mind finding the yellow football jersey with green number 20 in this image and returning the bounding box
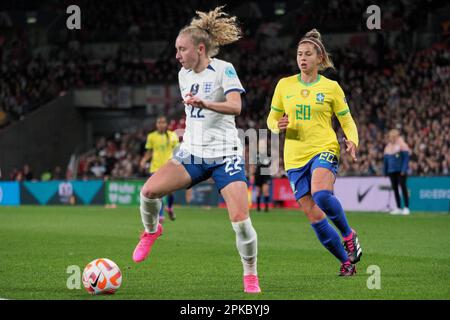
[267,74,359,170]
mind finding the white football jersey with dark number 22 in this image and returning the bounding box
[178,58,245,158]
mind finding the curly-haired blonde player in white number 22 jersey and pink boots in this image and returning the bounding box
[133,7,261,293]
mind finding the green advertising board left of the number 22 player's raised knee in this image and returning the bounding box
[105,180,145,206]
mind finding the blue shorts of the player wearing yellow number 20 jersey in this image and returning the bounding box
[287,152,339,201]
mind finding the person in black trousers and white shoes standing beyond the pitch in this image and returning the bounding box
[384,129,410,215]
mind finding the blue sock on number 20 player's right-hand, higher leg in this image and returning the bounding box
[313,190,352,238]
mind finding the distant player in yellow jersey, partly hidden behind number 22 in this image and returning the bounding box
[141,116,179,222]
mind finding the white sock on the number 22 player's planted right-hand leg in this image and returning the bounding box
[231,217,258,275]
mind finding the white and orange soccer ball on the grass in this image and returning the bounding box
[83,258,122,294]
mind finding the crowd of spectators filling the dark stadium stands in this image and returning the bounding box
[0,0,450,178]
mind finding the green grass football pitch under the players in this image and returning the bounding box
[0,206,450,300]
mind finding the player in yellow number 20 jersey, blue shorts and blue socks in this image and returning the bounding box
[267,29,362,276]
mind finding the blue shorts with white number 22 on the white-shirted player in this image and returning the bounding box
[173,151,248,192]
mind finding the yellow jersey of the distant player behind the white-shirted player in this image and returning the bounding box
[145,130,178,173]
